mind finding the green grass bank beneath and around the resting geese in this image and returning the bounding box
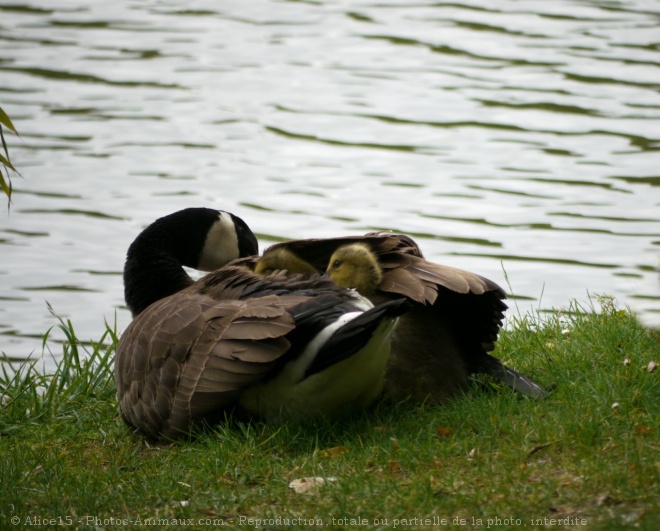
[0,298,660,530]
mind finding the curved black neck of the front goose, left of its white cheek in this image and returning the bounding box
[124,208,230,316]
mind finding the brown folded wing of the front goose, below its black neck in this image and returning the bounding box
[115,289,295,437]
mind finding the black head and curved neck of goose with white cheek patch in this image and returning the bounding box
[124,208,258,316]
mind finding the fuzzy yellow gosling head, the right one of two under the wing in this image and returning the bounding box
[326,243,383,297]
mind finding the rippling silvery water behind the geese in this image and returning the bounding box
[0,0,660,366]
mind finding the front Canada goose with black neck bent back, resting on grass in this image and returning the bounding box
[115,208,408,438]
